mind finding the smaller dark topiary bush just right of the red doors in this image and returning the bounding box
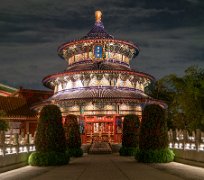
[119,114,140,156]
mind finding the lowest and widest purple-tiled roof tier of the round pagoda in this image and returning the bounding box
[33,88,166,107]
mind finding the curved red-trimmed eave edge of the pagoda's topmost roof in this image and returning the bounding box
[57,39,140,59]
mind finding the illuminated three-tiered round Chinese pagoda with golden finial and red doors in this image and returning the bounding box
[35,11,164,144]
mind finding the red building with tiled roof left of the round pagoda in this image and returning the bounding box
[0,84,53,135]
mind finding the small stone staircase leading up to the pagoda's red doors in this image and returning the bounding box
[89,142,112,154]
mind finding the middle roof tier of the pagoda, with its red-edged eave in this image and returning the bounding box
[42,63,155,89]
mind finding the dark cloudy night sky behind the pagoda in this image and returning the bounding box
[0,0,204,89]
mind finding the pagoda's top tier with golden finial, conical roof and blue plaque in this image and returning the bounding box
[58,11,139,65]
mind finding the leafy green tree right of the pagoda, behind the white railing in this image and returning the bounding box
[150,66,204,131]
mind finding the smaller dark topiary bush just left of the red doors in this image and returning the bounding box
[64,115,83,157]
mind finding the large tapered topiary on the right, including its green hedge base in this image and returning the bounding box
[135,105,174,163]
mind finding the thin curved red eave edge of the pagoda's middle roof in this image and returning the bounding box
[42,70,155,89]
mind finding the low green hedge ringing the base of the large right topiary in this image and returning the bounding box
[135,148,175,163]
